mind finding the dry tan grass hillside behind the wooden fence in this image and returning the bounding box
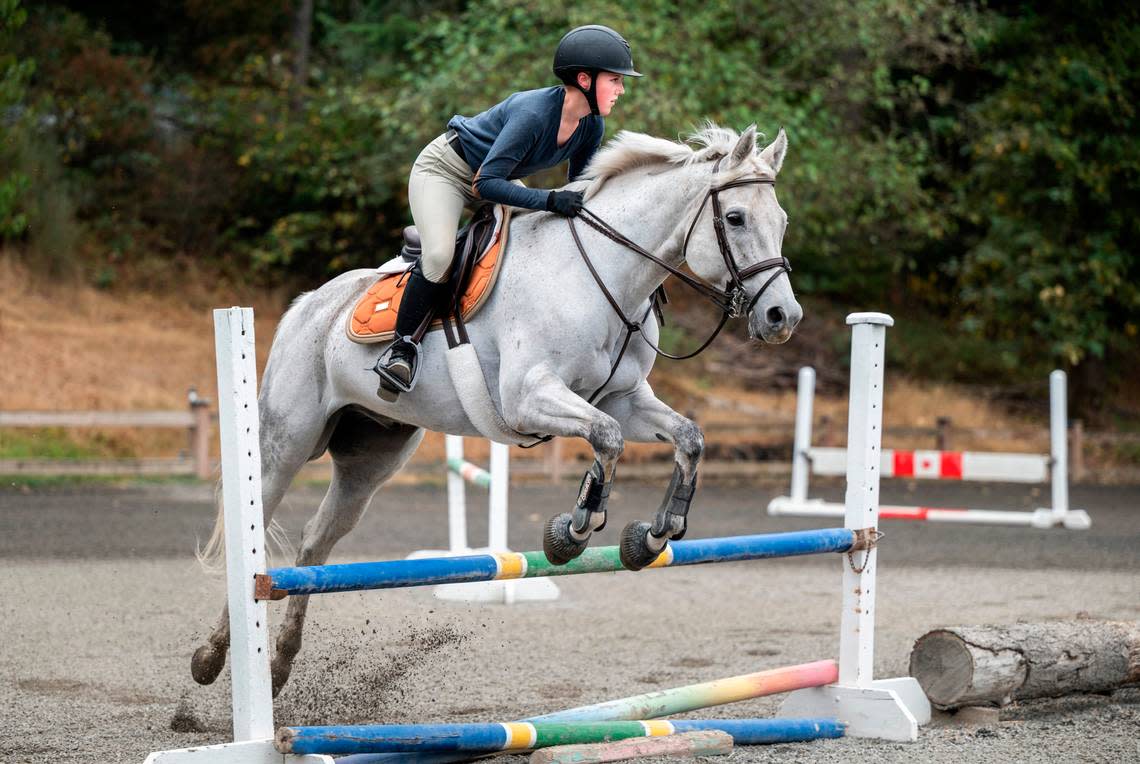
[0,259,1044,472]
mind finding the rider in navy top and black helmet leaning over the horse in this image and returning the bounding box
[374,25,641,398]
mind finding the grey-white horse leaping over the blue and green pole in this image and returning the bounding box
[192,125,803,693]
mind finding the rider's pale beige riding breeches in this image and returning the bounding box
[408,135,521,284]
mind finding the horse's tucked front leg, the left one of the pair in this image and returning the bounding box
[505,365,625,566]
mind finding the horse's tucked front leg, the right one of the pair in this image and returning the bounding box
[600,381,705,570]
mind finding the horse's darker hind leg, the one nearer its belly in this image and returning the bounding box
[271,413,423,696]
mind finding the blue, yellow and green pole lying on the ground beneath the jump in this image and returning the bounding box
[274,718,846,755]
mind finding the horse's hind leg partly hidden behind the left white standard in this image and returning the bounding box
[190,406,333,684]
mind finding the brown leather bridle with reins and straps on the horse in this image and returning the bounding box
[567,157,791,403]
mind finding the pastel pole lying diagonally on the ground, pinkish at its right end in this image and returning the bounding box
[337,660,839,764]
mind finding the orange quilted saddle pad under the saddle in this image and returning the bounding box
[345,205,511,344]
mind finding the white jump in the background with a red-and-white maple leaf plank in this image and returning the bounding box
[768,366,1091,530]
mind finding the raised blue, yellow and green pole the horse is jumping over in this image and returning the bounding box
[254,528,872,600]
